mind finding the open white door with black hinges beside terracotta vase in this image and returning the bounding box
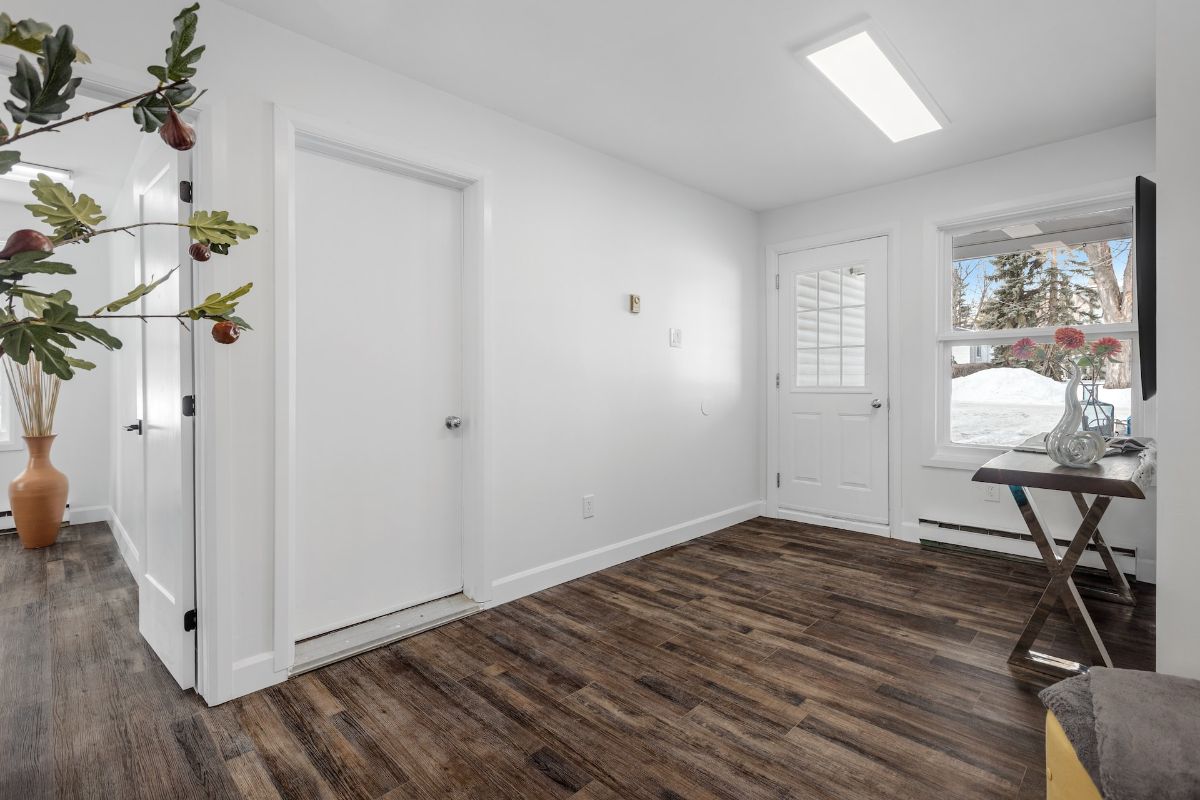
[136,154,196,688]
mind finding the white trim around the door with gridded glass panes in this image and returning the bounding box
[762,222,904,536]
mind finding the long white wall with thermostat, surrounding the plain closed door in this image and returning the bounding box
[28,0,763,700]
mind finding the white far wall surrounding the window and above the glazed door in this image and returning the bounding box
[760,121,1154,579]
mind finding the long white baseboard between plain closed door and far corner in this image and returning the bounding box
[485,500,763,608]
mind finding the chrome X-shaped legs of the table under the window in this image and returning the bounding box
[1008,486,1113,675]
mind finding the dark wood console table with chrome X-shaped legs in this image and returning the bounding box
[972,435,1157,675]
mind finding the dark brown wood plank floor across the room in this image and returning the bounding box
[0,519,1154,800]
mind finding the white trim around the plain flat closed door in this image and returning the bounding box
[274,104,492,673]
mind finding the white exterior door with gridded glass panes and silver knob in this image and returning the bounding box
[778,236,888,524]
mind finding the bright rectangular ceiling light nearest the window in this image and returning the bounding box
[796,22,948,142]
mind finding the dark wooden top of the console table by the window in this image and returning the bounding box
[971,435,1157,500]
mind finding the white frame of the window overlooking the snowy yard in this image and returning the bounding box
[925,193,1152,469]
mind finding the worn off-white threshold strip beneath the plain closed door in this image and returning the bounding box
[288,594,481,675]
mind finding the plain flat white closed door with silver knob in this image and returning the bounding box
[292,149,470,640]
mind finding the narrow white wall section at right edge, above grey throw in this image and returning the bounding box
[1157,0,1200,678]
